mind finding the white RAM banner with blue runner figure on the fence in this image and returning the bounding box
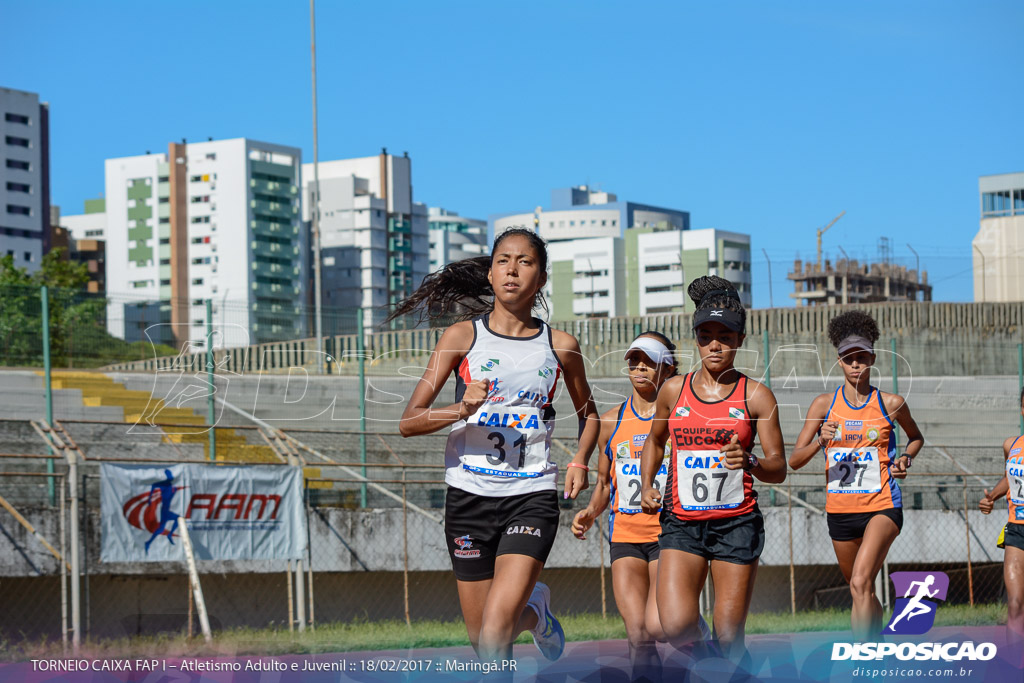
[100,463,306,562]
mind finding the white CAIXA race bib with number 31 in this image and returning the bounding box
[463,405,548,477]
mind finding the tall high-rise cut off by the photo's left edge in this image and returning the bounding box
[0,88,50,272]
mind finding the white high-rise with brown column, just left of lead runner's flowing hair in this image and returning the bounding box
[302,150,430,336]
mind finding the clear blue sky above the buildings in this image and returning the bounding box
[0,0,1024,306]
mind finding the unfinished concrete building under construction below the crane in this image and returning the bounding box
[786,258,932,306]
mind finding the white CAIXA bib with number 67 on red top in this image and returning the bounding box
[676,451,743,510]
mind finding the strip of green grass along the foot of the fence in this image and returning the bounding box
[0,604,1007,660]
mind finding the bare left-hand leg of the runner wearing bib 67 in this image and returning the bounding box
[657,547,708,648]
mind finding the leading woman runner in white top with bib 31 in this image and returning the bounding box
[392,228,600,660]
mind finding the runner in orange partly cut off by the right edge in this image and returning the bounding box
[978,391,1024,643]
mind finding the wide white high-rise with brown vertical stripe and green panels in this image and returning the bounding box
[103,138,307,347]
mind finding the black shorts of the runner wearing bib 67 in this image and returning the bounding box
[657,507,765,564]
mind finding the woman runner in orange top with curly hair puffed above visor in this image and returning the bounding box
[790,310,925,640]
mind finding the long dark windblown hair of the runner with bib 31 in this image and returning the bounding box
[384,227,548,324]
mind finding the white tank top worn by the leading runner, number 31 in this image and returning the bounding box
[444,314,562,497]
